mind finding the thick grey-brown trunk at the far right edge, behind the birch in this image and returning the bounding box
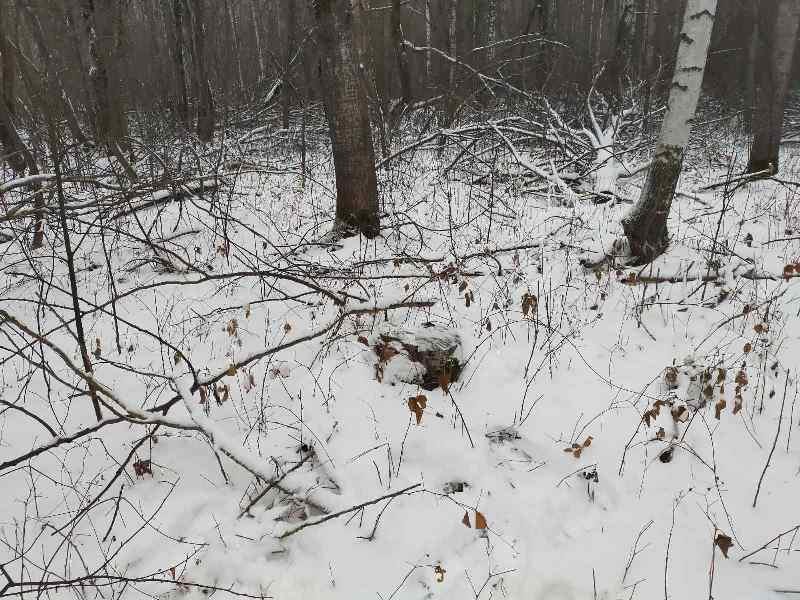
[747,0,800,175]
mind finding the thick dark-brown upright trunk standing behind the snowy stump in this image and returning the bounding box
[314,0,380,238]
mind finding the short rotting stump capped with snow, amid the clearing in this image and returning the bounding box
[372,325,463,390]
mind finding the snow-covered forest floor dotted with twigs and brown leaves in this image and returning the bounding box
[0,115,800,600]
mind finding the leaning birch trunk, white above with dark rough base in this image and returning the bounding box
[622,0,717,264]
